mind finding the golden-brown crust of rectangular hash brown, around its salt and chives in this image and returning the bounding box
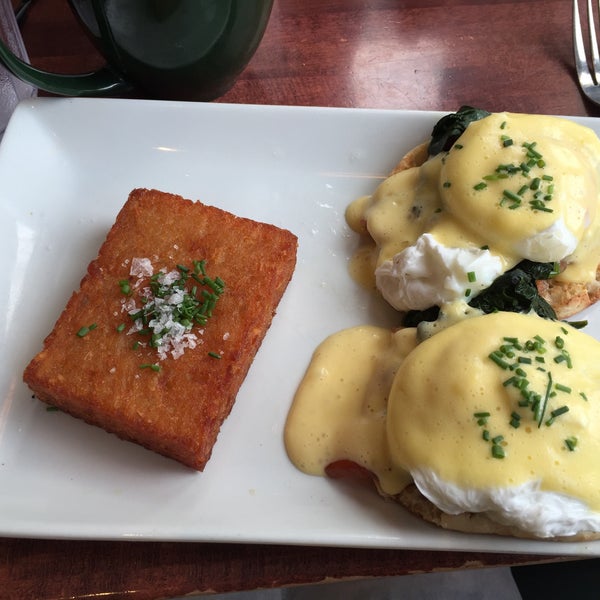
[24,189,297,470]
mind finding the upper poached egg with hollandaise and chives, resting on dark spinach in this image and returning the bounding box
[347,113,600,310]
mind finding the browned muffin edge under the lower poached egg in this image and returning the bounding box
[394,484,600,542]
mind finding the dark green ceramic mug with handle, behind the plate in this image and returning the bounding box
[0,0,273,100]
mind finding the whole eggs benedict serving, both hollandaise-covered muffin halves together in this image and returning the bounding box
[285,109,600,541]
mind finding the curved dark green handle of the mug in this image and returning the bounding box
[0,10,132,96]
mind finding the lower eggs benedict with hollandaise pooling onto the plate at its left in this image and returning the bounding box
[285,312,600,540]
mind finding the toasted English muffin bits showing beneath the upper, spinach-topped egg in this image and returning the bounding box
[390,142,600,319]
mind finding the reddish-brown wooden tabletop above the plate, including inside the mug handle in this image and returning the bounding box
[16,0,600,115]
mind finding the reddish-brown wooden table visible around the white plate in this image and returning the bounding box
[0,0,598,600]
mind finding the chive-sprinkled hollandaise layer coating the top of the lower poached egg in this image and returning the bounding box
[387,313,600,512]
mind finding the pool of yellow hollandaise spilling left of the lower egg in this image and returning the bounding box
[285,326,416,494]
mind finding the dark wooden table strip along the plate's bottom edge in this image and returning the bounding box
[0,539,568,600]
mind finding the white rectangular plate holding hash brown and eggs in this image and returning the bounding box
[0,99,600,555]
